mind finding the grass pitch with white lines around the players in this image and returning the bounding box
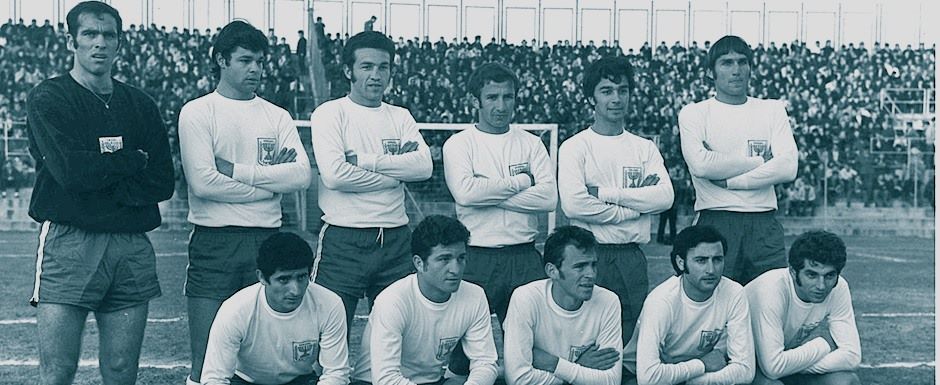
[0,232,936,385]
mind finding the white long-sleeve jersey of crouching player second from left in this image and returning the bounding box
[352,274,498,385]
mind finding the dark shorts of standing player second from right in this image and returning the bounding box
[597,243,650,344]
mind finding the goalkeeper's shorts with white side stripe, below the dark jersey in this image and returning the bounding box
[30,221,161,313]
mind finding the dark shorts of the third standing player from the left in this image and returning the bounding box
[313,224,414,300]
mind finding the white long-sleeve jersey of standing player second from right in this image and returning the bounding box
[558,128,674,244]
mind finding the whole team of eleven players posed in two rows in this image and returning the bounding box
[27,1,860,385]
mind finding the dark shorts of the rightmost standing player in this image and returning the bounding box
[696,210,787,285]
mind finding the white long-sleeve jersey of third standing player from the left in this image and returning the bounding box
[310,96,433,228]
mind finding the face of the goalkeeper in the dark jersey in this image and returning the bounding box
[67,13,120,76]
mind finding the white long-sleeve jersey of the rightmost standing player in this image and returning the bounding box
[679,97,799,212]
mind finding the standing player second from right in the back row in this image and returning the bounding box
[558,57,673,342]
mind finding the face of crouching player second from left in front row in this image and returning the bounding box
[414,242,467,302]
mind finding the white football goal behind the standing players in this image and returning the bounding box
[293,120,558,234]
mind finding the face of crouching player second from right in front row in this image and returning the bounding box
[678,242,725,301]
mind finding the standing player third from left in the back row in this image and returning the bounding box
[310,31,432,326]
